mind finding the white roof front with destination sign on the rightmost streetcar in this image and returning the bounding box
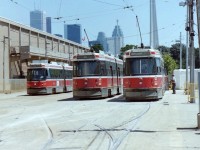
[124,48,162,58]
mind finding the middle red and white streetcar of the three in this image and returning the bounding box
[73,51,123,98]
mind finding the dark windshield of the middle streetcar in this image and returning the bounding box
[73,61,100,77]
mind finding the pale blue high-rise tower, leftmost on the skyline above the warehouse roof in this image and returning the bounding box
[30,10,46,31]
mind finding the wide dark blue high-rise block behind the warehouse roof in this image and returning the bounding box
[64,24,82,44]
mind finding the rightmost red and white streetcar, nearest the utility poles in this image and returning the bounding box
[123,49,168,100]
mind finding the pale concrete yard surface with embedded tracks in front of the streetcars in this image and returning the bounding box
[0,91,200,150]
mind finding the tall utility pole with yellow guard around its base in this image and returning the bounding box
[188,0,195,103]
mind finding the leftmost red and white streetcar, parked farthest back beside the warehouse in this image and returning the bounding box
[27,60,72,95]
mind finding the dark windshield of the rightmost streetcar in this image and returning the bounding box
[124,58,157,76]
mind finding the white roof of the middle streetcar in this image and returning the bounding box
[72,52,123,64]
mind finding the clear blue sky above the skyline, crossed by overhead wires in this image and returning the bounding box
[0,0,198,47]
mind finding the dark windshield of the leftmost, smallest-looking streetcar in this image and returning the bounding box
[27,68,47,81]
